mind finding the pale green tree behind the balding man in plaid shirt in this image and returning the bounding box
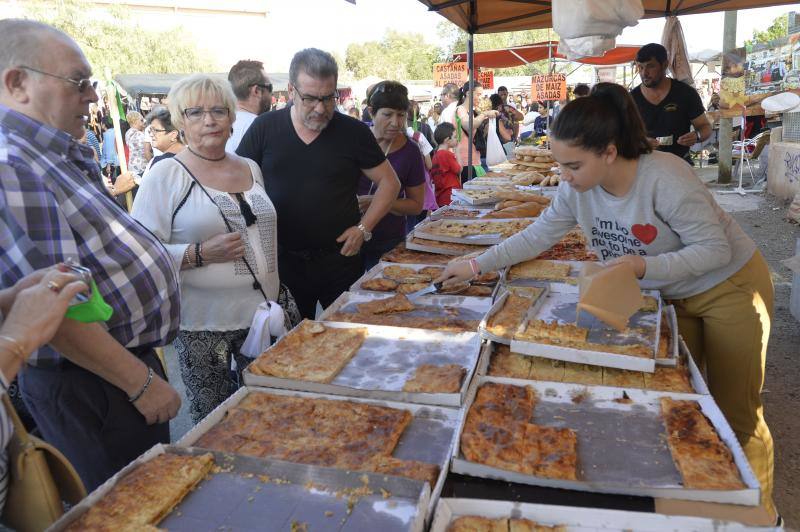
[25,0,214,76]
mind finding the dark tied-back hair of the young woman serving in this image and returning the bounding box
[551,83,653,159]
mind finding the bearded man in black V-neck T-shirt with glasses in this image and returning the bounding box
[236,48,400,319]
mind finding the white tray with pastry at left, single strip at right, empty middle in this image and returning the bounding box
[452,377,760,506]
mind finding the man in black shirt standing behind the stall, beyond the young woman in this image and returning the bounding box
[631,43,711,158]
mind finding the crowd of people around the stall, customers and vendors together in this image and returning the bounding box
[0,19,772,524]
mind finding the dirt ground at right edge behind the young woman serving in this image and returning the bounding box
[713,187,800,529]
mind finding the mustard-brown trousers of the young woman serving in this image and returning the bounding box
[670,250,775,513]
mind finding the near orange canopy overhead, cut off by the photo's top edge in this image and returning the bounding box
[419,0,796,34]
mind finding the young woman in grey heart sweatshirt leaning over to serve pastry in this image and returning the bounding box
[438,83,773,510]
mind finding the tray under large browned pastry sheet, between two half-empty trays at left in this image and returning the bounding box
[176,386,463,520]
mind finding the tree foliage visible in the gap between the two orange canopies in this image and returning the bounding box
[436,20,558,76]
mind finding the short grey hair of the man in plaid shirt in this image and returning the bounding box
[0,18,75,72]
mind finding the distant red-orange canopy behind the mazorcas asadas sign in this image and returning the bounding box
[453,41,640,68]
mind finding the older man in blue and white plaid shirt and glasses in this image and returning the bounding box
[0,19,180,490]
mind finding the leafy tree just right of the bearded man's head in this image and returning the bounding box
[344,30,441,80]
